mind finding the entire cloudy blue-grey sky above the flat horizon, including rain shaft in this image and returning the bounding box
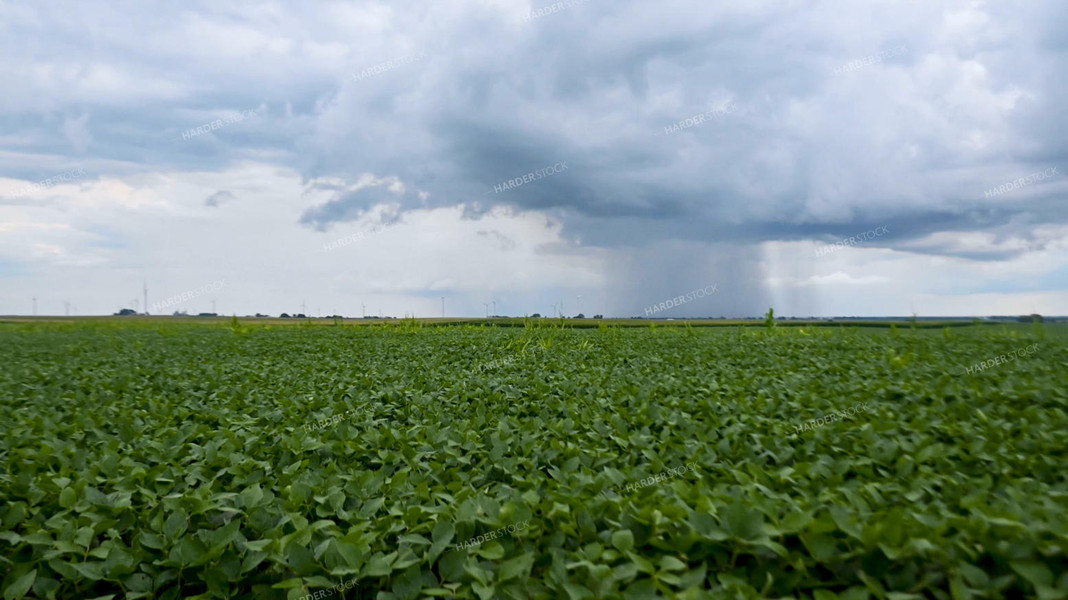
[0,0,1068,318]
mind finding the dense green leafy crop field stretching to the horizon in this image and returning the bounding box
[0,317,1068,600]
